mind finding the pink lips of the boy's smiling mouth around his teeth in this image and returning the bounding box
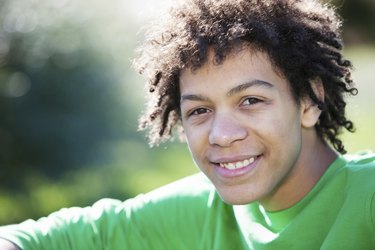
[213,155,262,179]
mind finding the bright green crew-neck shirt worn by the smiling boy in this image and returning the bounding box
[0,153,375,250]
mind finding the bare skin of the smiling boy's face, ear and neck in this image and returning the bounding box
[179,47,337,211]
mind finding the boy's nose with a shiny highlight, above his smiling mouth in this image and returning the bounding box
[208,114,247,147]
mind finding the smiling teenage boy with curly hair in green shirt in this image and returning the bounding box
[0,0,375,250]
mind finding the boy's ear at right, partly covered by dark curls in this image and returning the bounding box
[301,78,324,128]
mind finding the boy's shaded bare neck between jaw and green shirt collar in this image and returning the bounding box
[260,129,338,211]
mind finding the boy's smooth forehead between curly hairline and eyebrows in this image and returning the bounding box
[180,47,289,93]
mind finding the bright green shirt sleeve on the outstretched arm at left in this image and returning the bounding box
[0,174,214,250]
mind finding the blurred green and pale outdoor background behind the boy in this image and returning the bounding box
[0,0,375,225]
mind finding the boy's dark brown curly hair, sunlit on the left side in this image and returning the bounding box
[135,0,357,153]
